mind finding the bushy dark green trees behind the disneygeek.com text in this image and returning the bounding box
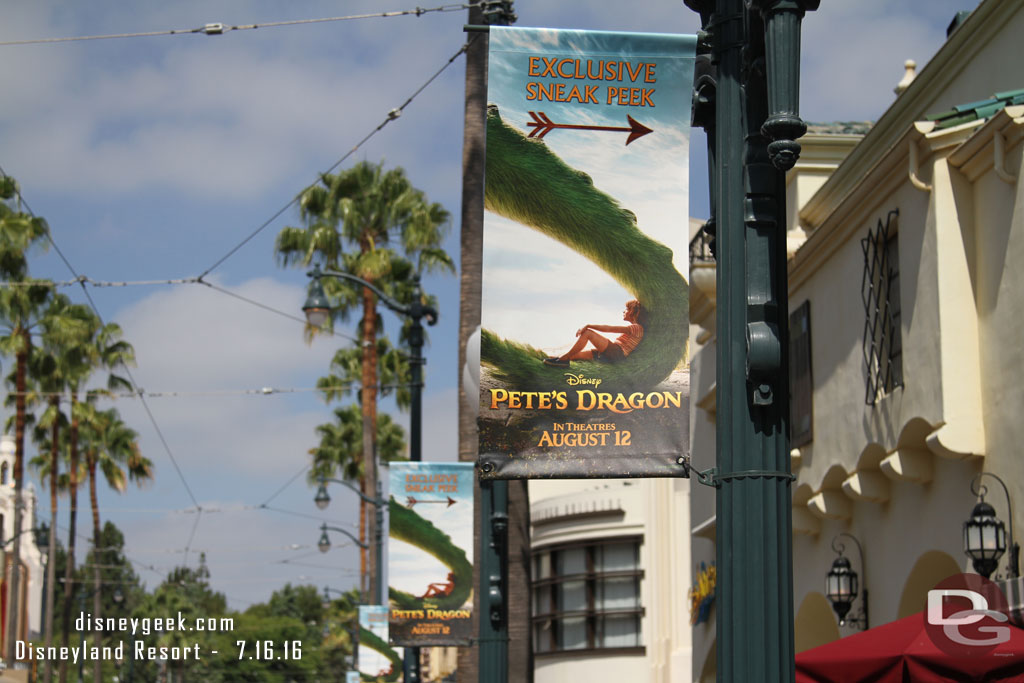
[37,522,360,683]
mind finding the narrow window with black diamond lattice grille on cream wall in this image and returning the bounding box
[860,211,903,405]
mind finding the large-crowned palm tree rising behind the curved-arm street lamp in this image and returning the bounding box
[274,162,455,602]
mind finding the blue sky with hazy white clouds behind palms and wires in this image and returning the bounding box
[0,0,978,609]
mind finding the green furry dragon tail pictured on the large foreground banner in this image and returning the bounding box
[480,106,689,391]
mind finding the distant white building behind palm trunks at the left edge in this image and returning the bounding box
[0,434,46,639]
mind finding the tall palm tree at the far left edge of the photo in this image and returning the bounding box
[0,176,52,661]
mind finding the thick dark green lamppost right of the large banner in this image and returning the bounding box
[687,0,818,683]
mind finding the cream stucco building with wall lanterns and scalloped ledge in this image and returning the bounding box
[690,0,1024,681]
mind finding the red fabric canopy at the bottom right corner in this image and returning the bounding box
[797,612,1024,683]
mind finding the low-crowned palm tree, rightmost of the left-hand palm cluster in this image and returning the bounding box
[81,405,153,681]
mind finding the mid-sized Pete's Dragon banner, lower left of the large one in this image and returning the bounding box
[388,463,474,646]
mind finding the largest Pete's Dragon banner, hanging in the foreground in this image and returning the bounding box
[478,27,696,479]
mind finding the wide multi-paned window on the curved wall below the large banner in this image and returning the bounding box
[531,538,643,653]
